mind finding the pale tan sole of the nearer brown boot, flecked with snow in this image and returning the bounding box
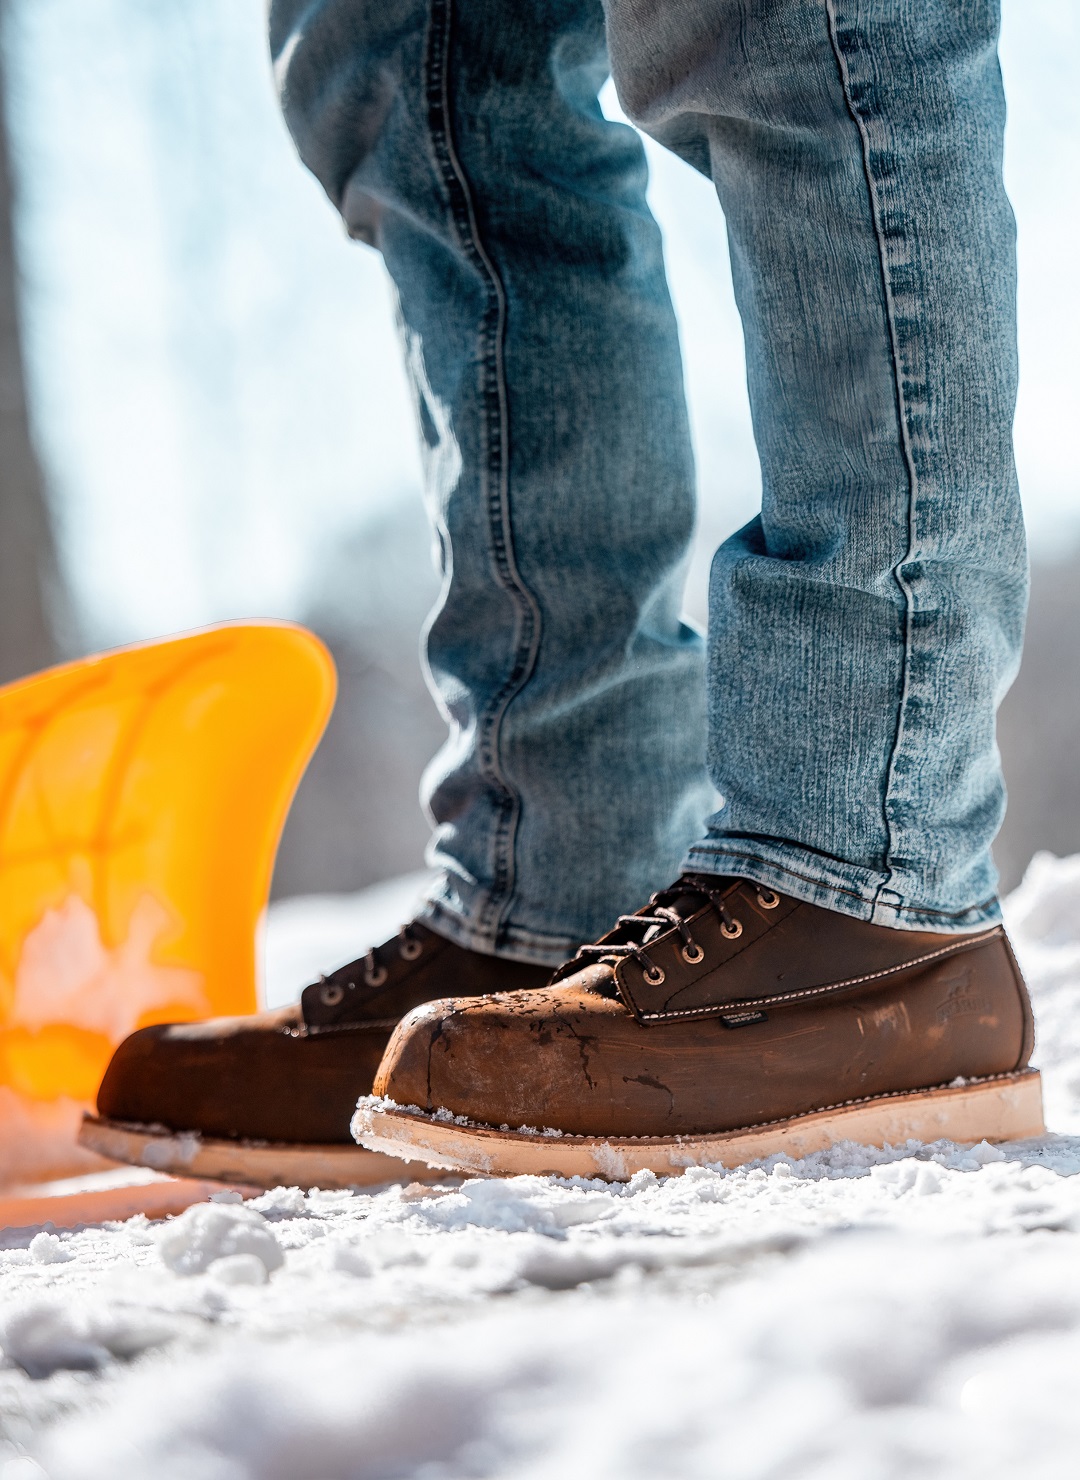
[352,1069,1046,1181]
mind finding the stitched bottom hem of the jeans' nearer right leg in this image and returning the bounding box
[684,838,1002,935]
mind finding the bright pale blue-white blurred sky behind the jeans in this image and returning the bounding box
[6,0,1080,644]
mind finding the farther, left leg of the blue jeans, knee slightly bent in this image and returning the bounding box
[271,0,715,963]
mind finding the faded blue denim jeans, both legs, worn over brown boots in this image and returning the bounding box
[271,0,1027,962]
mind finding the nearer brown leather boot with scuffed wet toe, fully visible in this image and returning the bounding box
[352,875,1043,1180]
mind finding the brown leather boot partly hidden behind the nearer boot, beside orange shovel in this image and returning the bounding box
[80,924,550,1187]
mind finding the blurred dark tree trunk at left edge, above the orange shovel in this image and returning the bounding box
[0,13,59,682]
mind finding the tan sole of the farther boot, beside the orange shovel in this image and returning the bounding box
[78,1114,438,1190]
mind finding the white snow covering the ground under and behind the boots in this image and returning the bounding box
[0,857,1080,1480]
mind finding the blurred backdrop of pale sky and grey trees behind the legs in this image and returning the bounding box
[0,0,1080,898]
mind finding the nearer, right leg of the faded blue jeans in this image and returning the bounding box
[608,0,1027,931]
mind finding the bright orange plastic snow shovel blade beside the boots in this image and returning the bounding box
[0,622,336,1185]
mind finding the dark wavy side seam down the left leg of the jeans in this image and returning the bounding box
[425,0,540,937]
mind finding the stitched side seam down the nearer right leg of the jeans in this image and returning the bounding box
[826,0,919,907]
